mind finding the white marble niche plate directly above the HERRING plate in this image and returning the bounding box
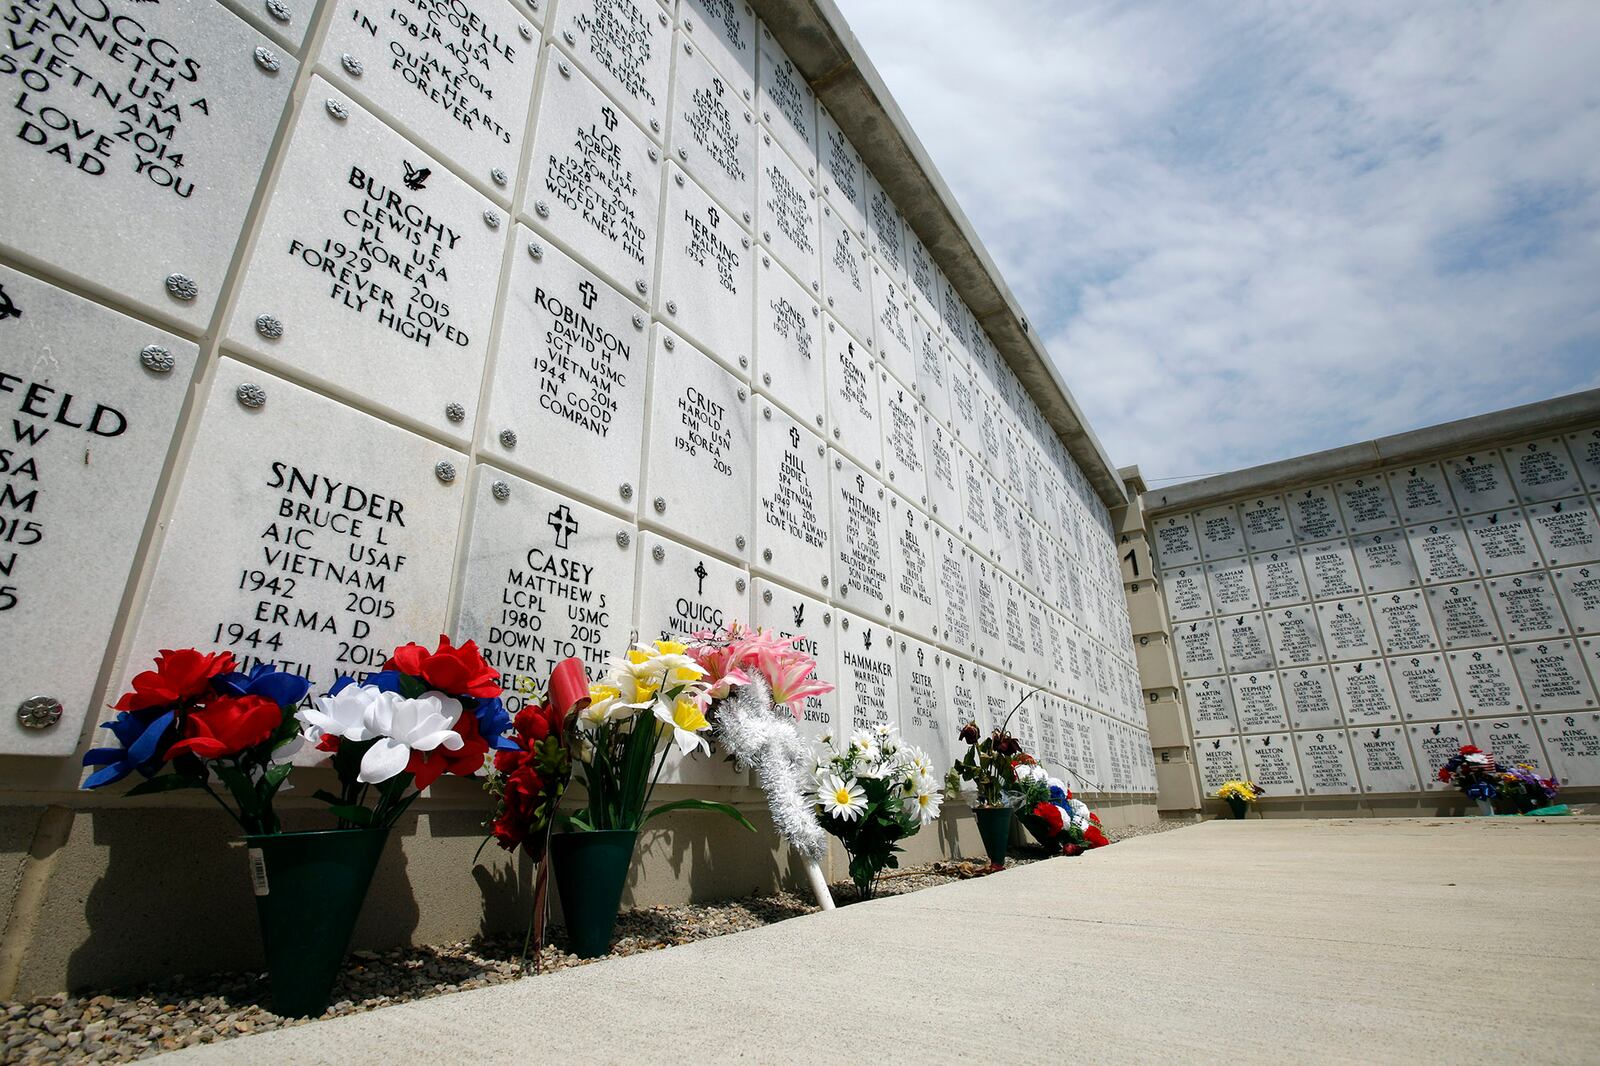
[670,32,755,226]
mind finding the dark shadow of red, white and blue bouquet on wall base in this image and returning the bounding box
[66,807,418,991]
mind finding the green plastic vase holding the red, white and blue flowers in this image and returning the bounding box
[245,828,389,1018]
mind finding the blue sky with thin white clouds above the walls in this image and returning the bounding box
[837,0,1600,479]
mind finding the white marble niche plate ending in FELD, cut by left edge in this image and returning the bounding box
[0,267,198,755]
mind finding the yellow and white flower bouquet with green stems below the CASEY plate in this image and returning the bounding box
[565,640,755,831]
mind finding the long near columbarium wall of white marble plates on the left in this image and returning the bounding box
[0,0,1155,994]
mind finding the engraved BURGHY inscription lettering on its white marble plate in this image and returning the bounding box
[288,165,472,347]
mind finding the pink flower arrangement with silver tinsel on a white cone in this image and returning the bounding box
[688,623,834,911]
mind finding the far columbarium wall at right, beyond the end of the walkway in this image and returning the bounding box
[1122,391,1600,815]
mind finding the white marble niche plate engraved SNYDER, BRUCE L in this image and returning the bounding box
[125,359,469,691]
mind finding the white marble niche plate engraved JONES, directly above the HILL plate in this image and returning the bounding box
[755,254,827,434]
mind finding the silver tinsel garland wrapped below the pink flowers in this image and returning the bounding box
[712,672,827,863]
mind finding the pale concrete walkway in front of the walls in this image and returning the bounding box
[170,818,1600,1066]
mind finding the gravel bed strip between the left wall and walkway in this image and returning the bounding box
[0,823,1184,1066]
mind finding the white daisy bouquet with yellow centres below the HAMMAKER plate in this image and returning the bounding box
[813,725,944,900]
